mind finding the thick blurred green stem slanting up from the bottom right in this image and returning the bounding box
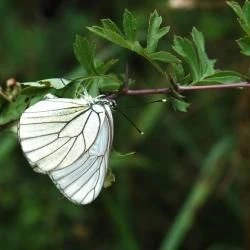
[160,136,234,250]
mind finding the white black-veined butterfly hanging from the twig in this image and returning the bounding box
[18,93,114,204]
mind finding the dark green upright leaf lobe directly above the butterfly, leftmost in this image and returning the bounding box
[73,35,98,75]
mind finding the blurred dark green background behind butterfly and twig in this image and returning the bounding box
[0,0,250,250]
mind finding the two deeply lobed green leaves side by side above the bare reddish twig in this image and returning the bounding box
[88,10,241,87]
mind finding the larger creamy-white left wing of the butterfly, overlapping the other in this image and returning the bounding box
[19,98,105,173]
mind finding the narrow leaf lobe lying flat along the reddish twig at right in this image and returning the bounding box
[202,71,243,83]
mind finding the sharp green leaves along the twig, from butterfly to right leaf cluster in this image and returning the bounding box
[0,6,245,125]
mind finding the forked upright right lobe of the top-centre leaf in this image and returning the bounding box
[146,10,170,52]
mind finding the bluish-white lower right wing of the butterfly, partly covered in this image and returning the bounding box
[49,112,113,204]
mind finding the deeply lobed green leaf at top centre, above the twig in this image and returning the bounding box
[87,10,176,87]
